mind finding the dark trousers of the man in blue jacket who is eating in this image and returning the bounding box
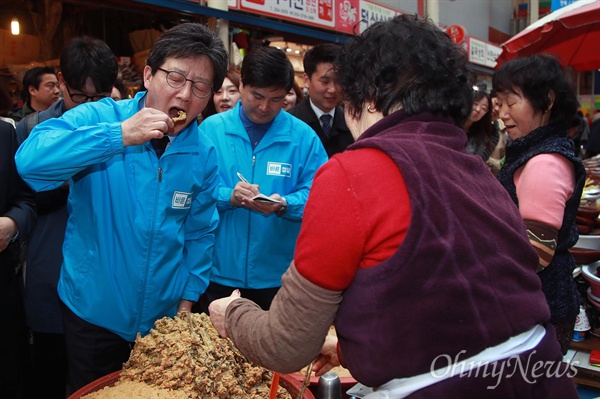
[63,304,133,392]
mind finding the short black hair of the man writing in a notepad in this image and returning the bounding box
[242,46,294,93]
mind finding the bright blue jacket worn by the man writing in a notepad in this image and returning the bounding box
[200,101,327,289]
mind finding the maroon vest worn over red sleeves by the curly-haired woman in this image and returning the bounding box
[335,111,550,386]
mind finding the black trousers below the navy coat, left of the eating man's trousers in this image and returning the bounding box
[31,331,67,399]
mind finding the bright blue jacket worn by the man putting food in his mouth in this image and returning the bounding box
[16,93,218,341]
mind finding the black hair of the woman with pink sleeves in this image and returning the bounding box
[492,54,578,128]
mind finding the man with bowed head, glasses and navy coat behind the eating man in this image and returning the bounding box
[17,36,119,399]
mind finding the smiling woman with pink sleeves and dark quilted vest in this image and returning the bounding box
[493,55,585,353]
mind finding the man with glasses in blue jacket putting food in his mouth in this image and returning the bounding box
[16,23,227,390]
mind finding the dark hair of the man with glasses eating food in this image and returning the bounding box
[146,22,228,91]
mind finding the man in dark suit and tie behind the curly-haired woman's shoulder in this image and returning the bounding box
[290,43,354,157]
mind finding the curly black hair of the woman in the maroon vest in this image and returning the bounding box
[336,14,475,126]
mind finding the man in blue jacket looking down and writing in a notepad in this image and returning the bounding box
[200,47,327,310]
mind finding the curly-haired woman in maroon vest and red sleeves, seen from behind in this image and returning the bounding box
[209,15,578,399]
